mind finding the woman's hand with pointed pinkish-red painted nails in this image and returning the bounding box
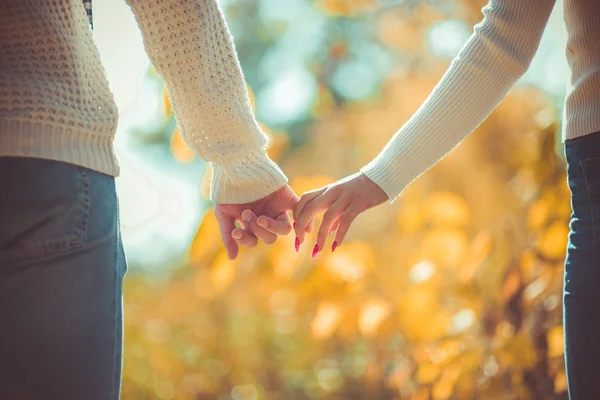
[294,172,389,258]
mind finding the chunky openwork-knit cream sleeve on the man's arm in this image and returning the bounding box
[128,0,287,204]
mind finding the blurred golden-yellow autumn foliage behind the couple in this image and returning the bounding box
[123,0,570,400]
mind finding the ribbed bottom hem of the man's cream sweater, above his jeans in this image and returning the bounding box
[0,120,119,176]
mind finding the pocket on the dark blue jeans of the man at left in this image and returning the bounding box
[0,158,90,255]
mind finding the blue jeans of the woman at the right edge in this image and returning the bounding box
[563,132,600,400]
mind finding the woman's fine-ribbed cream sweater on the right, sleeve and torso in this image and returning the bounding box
[361,0,600,201]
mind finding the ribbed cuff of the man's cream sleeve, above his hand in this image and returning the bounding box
[210,152,288,204]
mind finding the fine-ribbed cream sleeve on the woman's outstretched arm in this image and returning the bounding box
[361,0,555,201]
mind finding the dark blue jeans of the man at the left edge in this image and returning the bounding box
[0,157,127,400]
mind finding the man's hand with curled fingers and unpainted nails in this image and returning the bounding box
[215,185,298,260]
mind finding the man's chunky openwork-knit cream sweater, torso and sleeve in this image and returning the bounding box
[0,0,287,203]
